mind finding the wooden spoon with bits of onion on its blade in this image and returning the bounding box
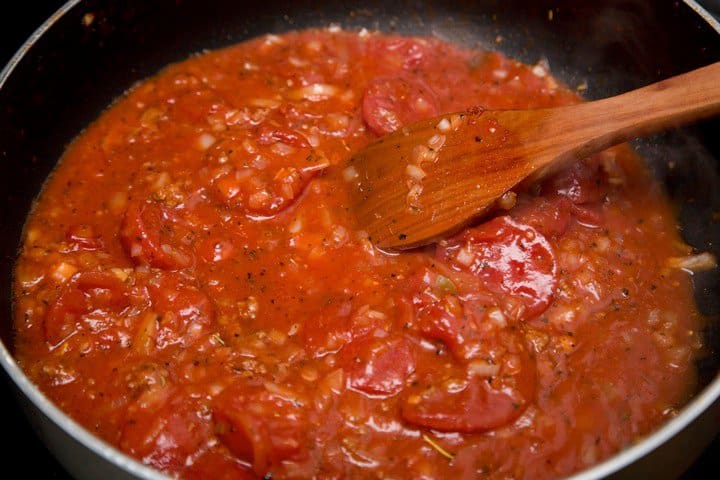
[349,62,720,249]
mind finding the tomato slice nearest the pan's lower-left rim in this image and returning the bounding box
[120,387,212,472]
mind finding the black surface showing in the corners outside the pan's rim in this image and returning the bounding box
[0,0,720,480]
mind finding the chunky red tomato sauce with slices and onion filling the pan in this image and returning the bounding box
[15,28,702,479]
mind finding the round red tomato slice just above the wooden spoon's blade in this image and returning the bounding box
[362,75,440,136]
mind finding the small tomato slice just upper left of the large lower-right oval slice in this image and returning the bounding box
[341,335,415,397]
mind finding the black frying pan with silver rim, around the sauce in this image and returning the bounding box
[0,0,720,478]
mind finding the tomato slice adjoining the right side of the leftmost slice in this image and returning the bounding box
[148,273,215,349]
